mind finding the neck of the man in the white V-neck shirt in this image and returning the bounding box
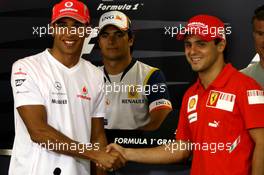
[49,48,81,68]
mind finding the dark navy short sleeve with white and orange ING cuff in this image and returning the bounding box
[146,69,172,112]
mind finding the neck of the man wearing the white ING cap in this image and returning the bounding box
[103,56,132,75]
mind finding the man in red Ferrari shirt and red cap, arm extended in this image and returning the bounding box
[105,15,264,175]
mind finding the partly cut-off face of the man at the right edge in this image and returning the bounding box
[253,19,264,61]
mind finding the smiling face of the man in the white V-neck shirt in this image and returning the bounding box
[53,18,87,54]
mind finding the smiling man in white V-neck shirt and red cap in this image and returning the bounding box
[9,0,125,175]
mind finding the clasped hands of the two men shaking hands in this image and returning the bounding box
[93,143,128,172]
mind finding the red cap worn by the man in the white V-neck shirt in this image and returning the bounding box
[51,0,90,24]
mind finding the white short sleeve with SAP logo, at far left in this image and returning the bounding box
[11,61,45,108]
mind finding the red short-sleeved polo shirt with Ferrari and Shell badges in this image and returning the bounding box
[176,64,264,175]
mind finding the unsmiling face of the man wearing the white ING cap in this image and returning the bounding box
[98,25,133,60]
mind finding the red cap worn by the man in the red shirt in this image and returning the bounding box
[176,14,226,41]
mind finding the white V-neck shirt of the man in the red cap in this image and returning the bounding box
[9,49,105,175]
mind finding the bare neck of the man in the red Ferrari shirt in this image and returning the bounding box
[198,59,225,89]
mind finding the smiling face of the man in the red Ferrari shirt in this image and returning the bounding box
[184,35,224,73]
